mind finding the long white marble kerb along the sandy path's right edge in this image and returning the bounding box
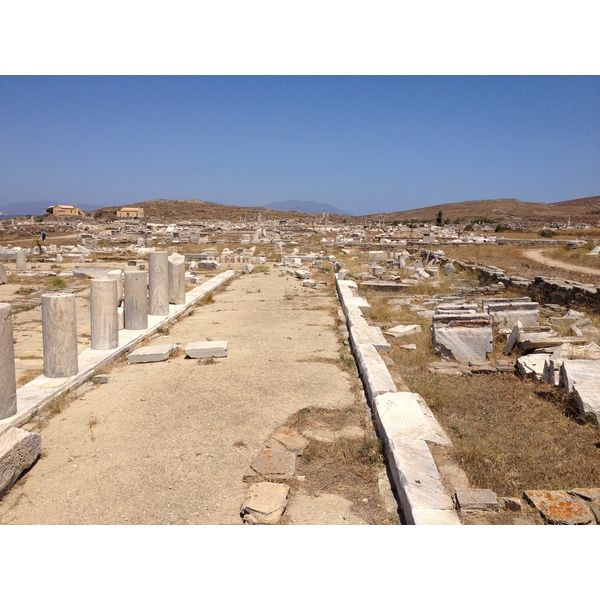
[336,276,460,525]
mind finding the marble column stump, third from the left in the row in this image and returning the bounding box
[90,277,119,350]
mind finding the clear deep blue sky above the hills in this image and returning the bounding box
[0,76,600,215]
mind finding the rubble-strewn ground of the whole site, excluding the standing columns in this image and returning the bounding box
[0,206,600,525]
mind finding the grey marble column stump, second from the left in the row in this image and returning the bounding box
[42,292,79,377]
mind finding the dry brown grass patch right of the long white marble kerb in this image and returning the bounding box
[358,286,600,497]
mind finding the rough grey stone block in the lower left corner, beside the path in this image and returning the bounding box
[0,427,42,497]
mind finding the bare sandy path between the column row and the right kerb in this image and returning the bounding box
[0,266,390,524]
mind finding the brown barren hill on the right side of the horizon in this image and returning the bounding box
[368,196,600,228]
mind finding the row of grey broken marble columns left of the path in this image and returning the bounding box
[0,252,185,419]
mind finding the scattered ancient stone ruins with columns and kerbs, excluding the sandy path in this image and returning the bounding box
[0,206,600,525]
